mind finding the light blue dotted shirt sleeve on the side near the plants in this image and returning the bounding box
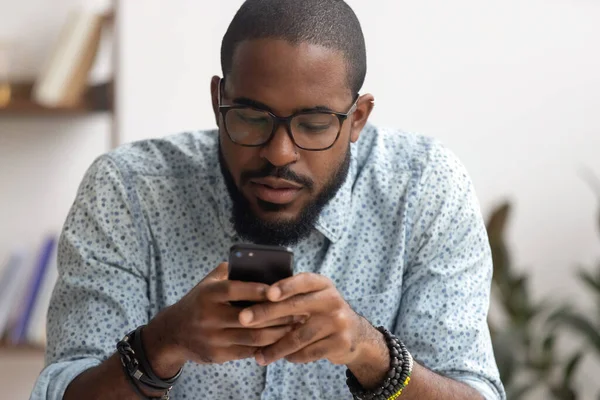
[396,145,506,400]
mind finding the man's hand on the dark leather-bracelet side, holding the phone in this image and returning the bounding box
[142,263,295,377]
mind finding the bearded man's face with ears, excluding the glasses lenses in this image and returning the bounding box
[212,39,372,244]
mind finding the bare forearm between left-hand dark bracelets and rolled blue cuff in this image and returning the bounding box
[63,353,168,400]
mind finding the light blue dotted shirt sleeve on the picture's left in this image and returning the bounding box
[31,156,149,400]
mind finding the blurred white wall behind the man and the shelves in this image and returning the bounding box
[0,0,600,398]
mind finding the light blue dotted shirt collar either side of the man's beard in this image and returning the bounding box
[208,143,357,243]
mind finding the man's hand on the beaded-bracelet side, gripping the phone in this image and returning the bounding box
[239,273,370,365]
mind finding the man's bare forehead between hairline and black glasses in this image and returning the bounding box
[226,39,352,115]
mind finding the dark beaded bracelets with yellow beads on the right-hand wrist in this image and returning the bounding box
[346,326,413,400]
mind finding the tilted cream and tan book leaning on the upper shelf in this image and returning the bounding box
[32,9,106,107]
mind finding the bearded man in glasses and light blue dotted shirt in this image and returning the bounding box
[32,0,504,400]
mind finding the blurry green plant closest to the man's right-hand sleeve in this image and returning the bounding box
[487,203,581,400]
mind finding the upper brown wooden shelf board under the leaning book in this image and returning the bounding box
[0,82,113,117]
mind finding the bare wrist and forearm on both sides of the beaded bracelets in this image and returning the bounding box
[348,329,483,400]
